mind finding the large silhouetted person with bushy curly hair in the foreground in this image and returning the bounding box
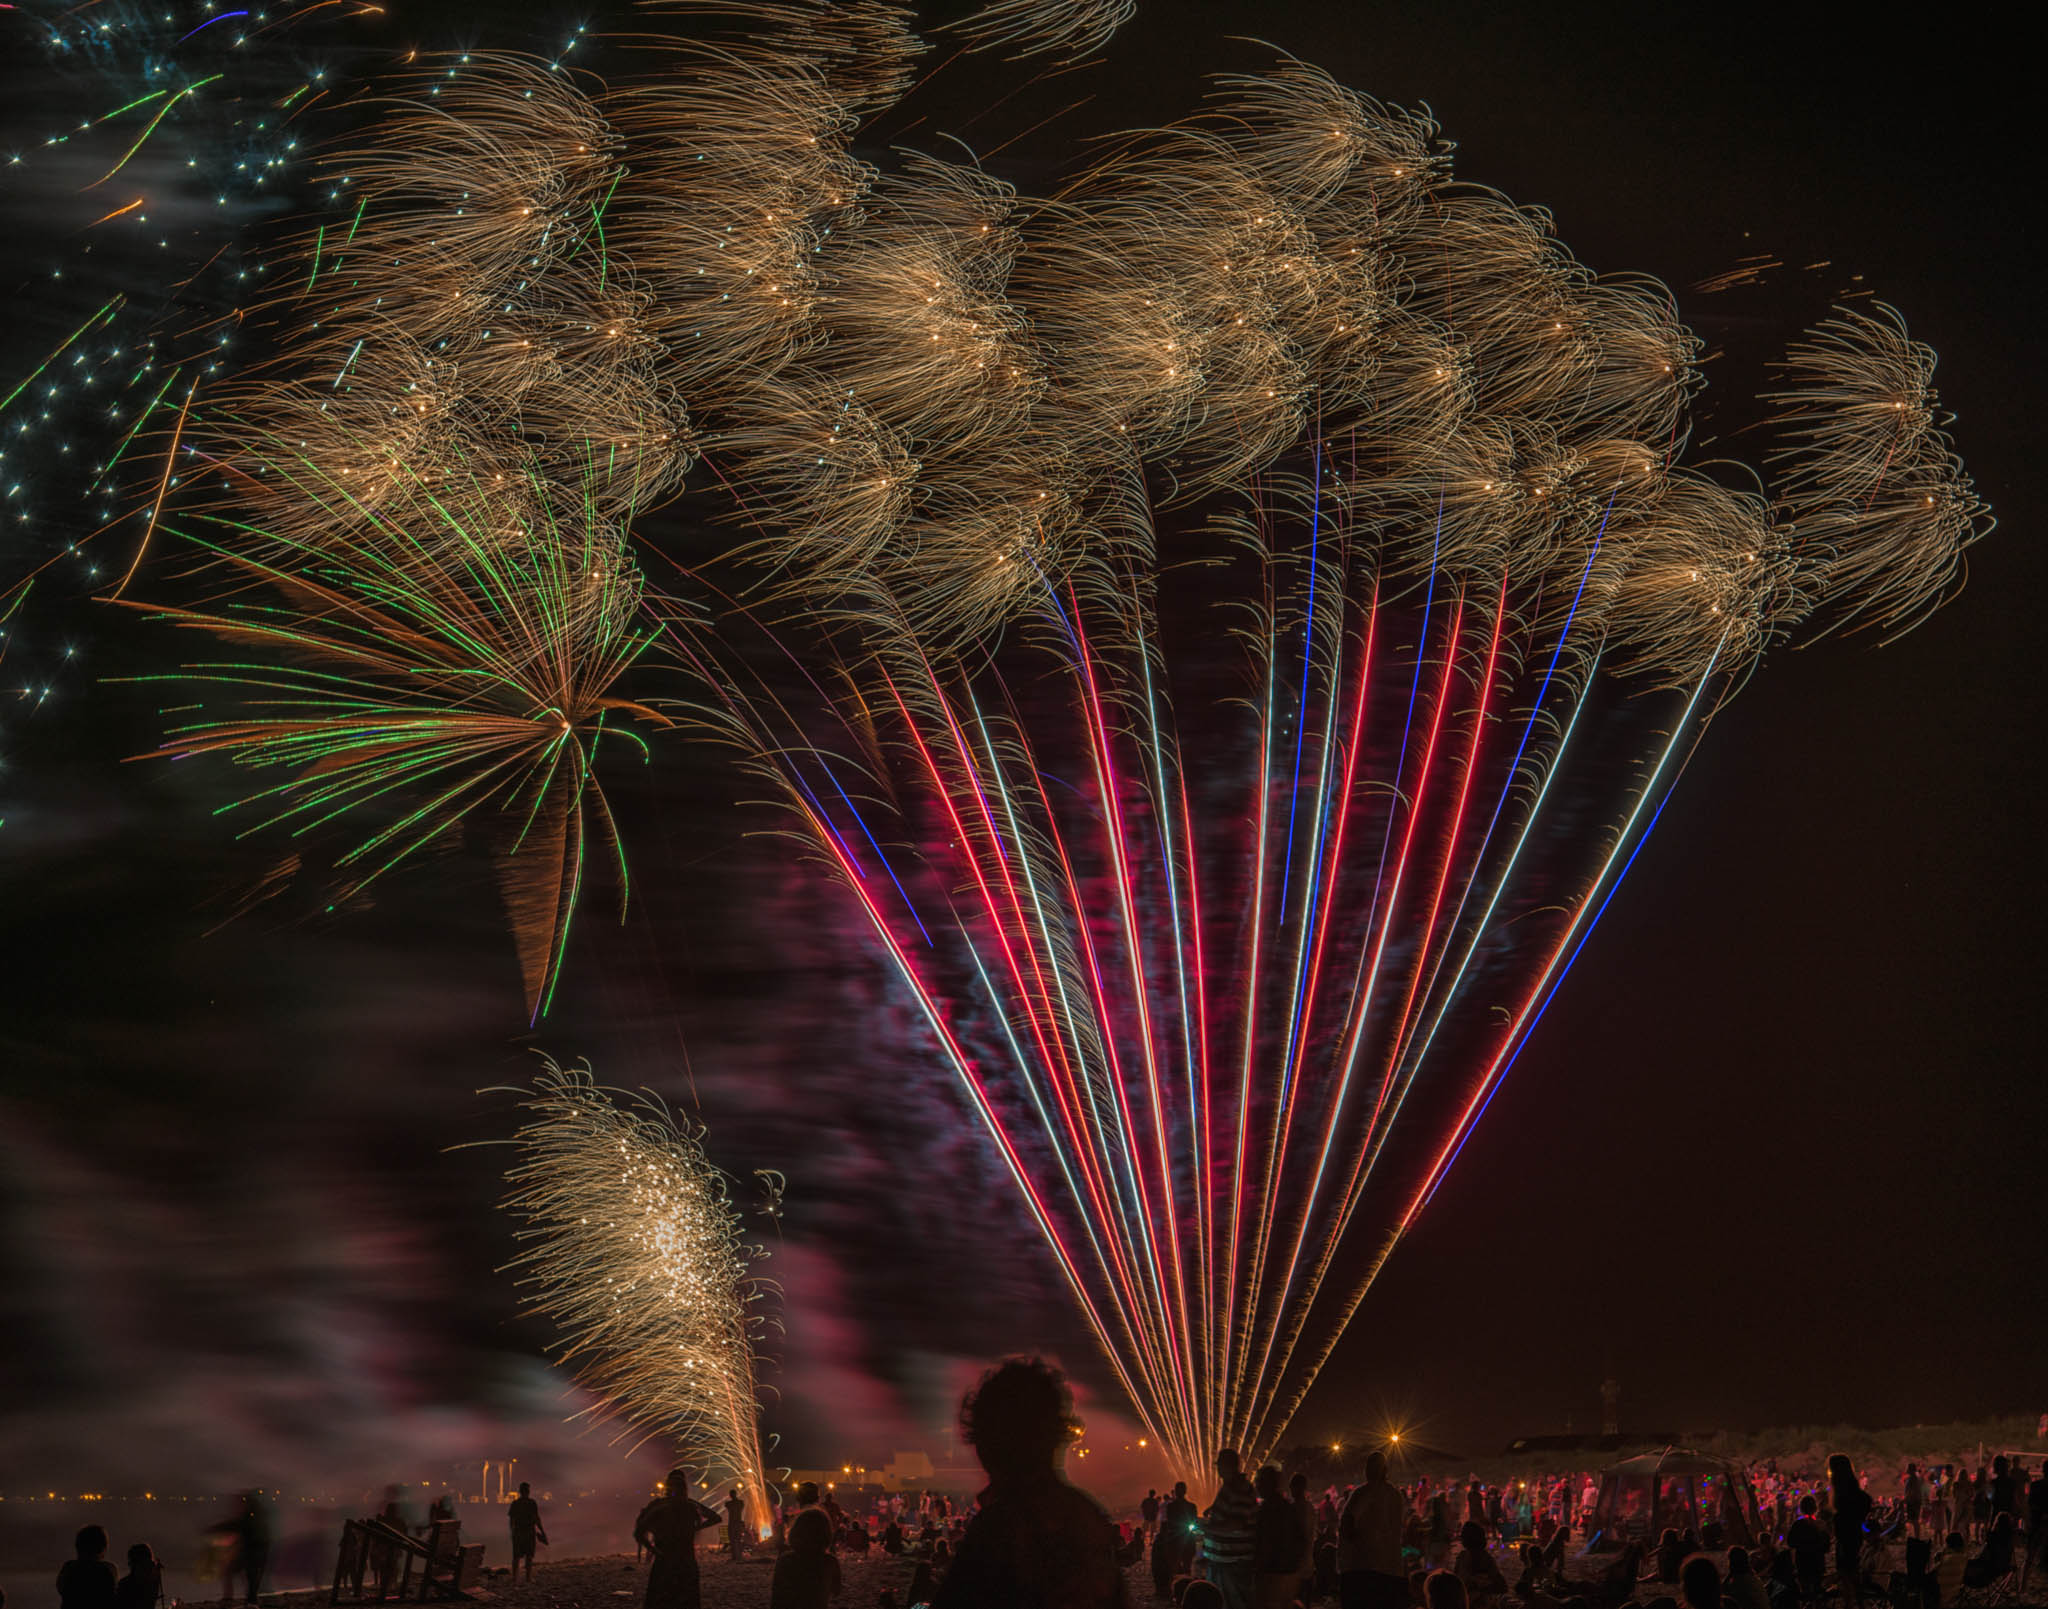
[932,1357,1124,1609]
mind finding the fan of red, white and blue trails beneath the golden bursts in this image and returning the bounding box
[725,470,1714,1476]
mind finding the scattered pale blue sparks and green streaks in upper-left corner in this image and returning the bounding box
[0,0,381,706]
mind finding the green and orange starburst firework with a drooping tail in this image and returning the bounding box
[123,440,666,1013]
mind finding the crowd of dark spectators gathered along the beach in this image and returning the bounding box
[39,1359,2048,1609]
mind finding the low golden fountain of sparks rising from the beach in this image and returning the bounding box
[504,1062,772,1535]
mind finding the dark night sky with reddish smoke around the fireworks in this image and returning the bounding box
[0,0,2048,1484]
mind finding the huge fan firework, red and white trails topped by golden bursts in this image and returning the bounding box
[136,0,1985,1472]
